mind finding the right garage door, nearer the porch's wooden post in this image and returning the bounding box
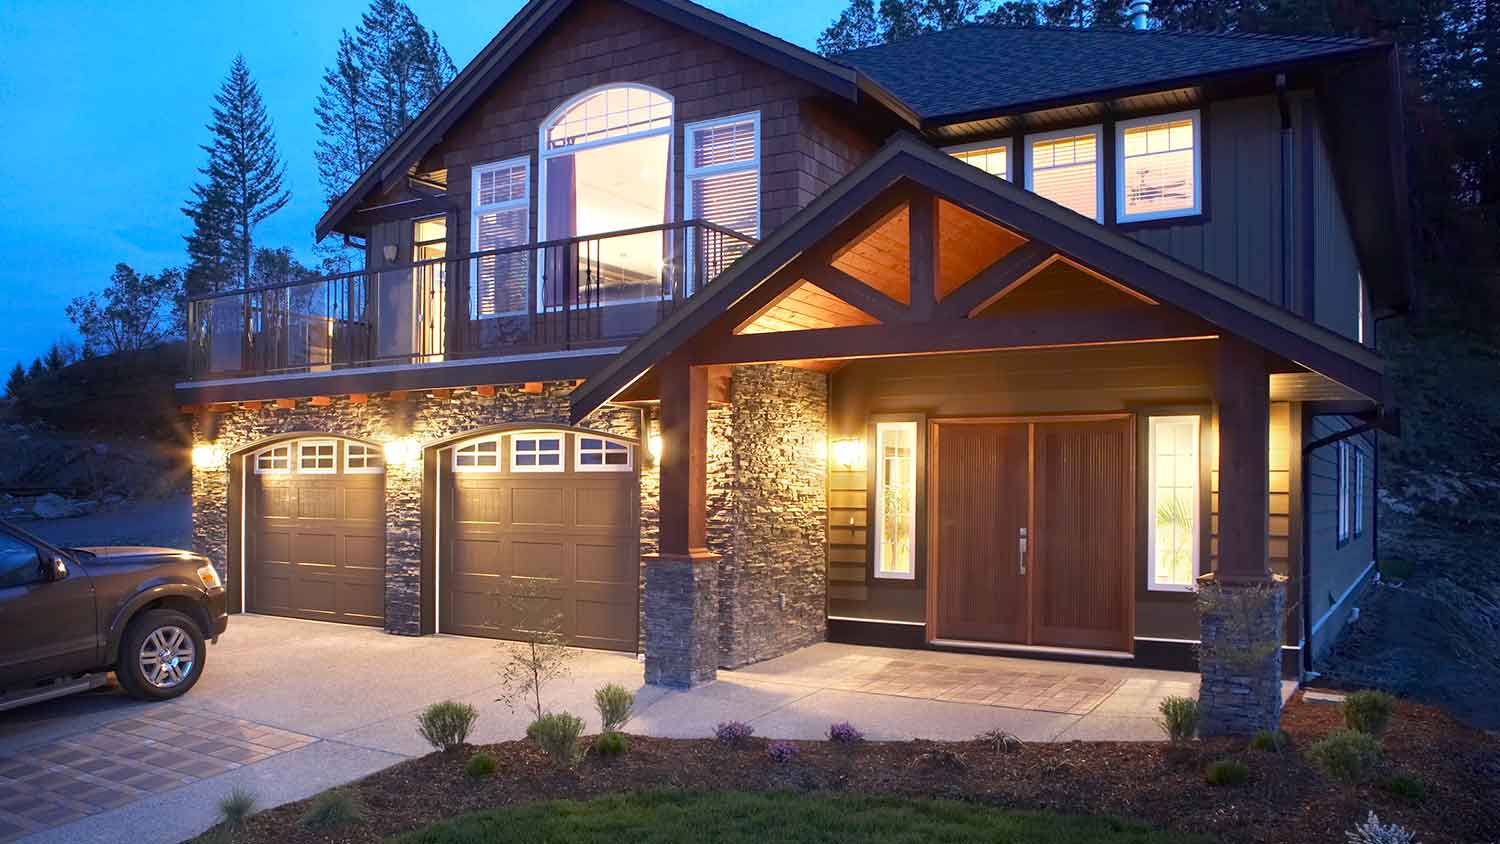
[438,430,641,652]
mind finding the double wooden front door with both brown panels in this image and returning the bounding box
[929,417,1136,651]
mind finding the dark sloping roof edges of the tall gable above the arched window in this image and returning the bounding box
[315,0,917,240]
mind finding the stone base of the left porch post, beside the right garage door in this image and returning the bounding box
[645,552,719,688]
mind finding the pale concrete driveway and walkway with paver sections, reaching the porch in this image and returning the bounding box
[0,616,1197,844]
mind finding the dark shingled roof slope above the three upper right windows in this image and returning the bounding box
[834,24,1388,123]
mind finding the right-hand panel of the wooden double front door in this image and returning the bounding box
[1032,418,1136,651]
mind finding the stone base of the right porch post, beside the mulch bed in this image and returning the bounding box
[1199,574,1287,736]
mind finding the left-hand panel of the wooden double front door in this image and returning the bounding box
[932,423,1028,643]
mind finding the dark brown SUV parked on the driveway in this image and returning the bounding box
[0,522,228,709]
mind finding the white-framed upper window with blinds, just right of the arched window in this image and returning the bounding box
[683,112,761,290]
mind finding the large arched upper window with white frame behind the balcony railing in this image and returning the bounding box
[537,84,672,310]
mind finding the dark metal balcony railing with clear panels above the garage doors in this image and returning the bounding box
[188,220,755,381]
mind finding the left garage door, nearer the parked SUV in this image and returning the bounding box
[245,438,386,625]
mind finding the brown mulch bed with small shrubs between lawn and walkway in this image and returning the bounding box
[214,696,1500,844]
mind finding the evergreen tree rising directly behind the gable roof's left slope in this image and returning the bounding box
[314,0,456,201]
